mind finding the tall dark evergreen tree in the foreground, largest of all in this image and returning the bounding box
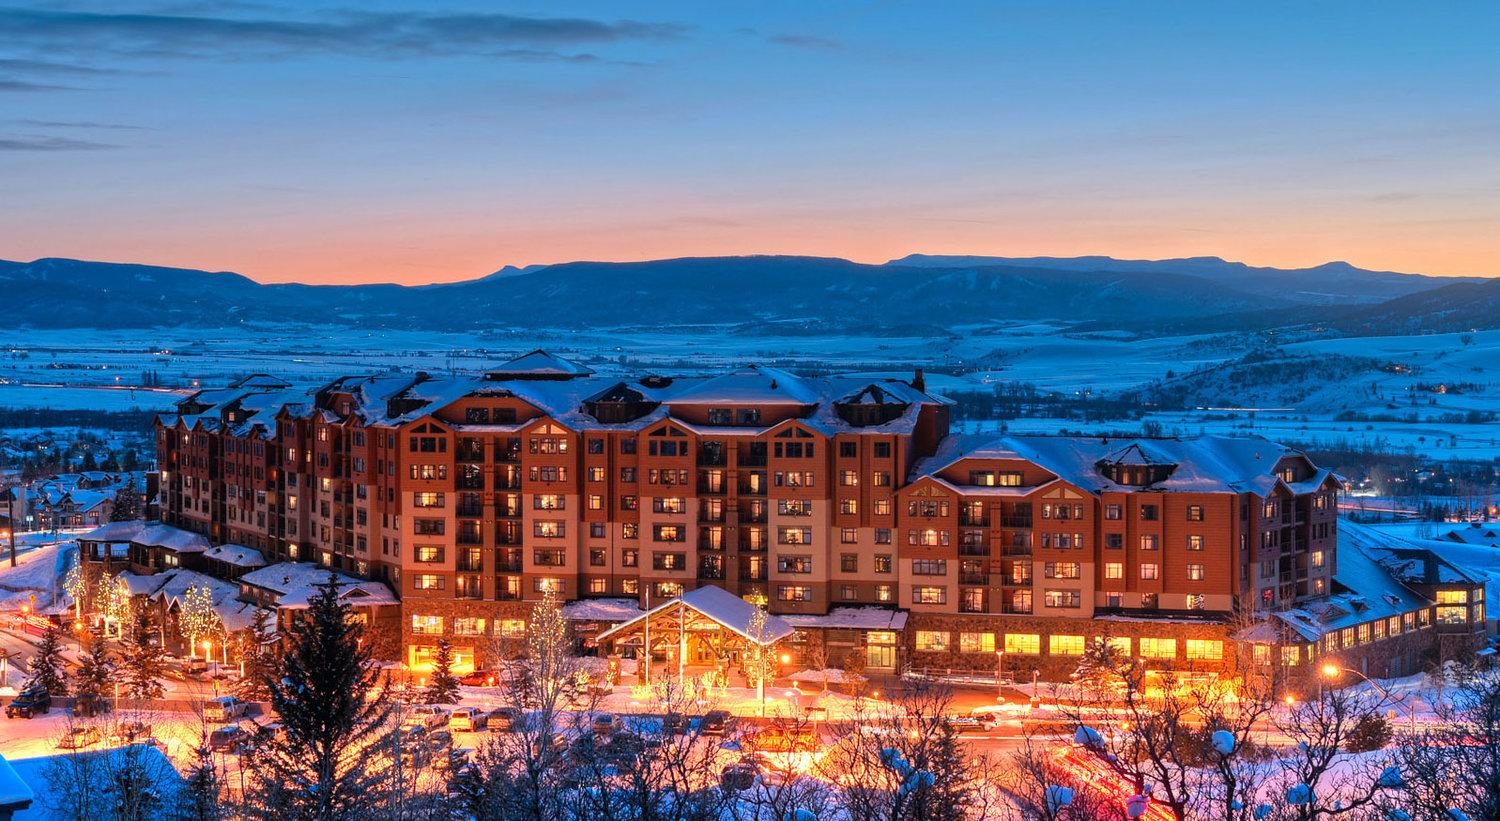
[252,573,390,821]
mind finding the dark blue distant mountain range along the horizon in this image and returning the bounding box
[0,255,1500,335]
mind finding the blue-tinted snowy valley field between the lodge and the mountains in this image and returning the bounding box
[0,323,1500,459]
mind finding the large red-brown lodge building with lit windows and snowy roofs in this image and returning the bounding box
[143,351,1485,681]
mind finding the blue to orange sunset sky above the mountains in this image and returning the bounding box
[0,0,1500,284]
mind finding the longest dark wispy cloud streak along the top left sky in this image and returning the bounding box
[0,8,687,60]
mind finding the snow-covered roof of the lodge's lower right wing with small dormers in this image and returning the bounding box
[912,434,1328,495]
